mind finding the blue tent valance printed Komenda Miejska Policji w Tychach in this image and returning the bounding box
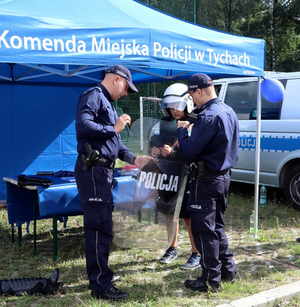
[0,15,264,76]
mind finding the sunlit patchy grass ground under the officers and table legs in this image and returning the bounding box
[0,185,300,307]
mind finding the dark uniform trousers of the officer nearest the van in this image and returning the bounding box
[189,174,236,286]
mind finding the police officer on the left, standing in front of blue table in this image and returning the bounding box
[75,65,149,300]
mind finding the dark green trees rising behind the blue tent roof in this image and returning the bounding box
[137,0,300,71]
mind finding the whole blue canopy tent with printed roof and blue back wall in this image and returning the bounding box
[0,0,264,203]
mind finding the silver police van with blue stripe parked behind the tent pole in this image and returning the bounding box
[215,72,300,208]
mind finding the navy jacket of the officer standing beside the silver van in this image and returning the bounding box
[177,98,239,172]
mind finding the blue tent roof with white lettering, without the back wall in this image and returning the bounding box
[0,0,265,82]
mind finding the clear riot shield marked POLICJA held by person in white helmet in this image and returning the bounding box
[113,101,190,256]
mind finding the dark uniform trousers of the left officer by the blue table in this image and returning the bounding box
[75,159,113,292]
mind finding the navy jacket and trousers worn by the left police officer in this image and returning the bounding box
[75,84,135,292]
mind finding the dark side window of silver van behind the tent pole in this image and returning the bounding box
[224,81,282,119]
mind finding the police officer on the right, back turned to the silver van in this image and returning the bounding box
[177,74,239,292]
